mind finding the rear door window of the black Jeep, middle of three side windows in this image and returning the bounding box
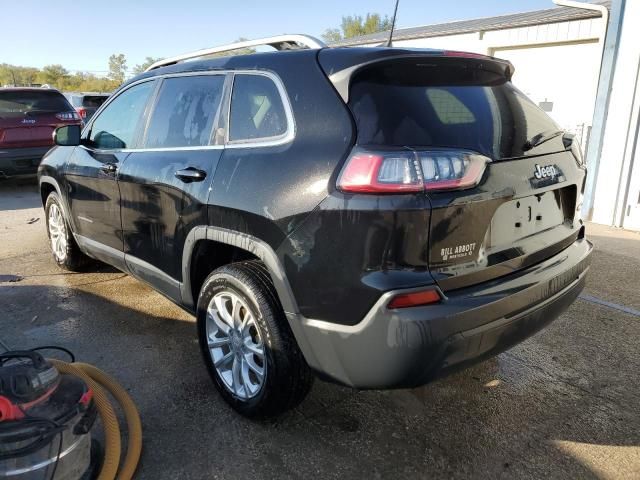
[144,75,225,148]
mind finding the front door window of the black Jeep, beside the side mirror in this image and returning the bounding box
[89,81,155,149]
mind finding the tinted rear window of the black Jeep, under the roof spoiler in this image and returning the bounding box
[349,62,564,159]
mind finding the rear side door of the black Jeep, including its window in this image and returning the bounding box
[118,73,227,300]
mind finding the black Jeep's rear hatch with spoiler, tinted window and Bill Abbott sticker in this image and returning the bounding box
[321,49,585,291]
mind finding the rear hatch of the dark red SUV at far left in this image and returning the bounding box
[0,89,80,148]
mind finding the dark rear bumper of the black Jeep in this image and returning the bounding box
[289,238,592,388]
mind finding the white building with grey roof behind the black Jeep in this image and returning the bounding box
[336,0,640,230]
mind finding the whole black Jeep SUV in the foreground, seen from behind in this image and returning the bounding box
[39,37,592,416]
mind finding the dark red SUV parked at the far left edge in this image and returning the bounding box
[0,88,81,178]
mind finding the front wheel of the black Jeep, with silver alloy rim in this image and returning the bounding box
[44,192,90,272]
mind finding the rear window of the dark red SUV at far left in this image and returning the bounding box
[0,90,71,117]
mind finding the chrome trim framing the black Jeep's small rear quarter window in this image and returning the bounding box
[225,70,296,148]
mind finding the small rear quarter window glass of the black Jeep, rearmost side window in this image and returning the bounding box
[229,74,287,141]
